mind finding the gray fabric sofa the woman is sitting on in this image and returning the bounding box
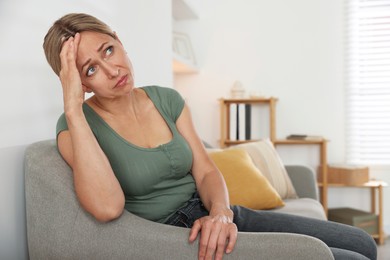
[25,140,333,260]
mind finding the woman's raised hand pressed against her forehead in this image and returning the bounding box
[60,33,85,113]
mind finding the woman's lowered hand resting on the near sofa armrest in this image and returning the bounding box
[189,212,238,260]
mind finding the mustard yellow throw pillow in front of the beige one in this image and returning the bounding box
[209,149,284,209]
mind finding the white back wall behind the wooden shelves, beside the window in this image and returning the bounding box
[174,0,390,235]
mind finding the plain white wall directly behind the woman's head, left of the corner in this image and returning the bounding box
[0,0,172,148]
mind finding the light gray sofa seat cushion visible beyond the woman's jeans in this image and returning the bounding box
[270,198,327,220]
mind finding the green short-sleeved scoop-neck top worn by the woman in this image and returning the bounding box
[57,86,196,222]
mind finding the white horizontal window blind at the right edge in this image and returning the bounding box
[346,0,390,166]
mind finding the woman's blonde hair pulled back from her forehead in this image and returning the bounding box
[43,13,117,75]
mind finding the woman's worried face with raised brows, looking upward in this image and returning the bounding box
[76,31,134,98]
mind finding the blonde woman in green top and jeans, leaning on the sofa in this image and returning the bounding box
[44,14,376,259]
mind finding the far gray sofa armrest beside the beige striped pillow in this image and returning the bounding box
[285,165,319,200]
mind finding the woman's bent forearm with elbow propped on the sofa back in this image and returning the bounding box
[66,109,124,221]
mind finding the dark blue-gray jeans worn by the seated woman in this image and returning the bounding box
[165,194,377,260]
